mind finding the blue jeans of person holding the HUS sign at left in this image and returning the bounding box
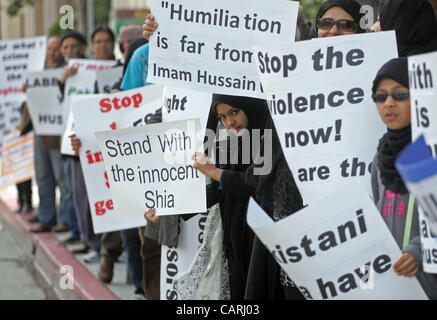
[34,135,68,227]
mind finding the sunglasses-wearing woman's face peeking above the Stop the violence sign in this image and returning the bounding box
[317,7,357,38]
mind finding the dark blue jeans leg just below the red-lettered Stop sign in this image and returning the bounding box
[121,229,144,294]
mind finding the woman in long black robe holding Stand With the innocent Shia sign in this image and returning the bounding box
[191,95,303,300]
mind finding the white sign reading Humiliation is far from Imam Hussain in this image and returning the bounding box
[147,0,299,98]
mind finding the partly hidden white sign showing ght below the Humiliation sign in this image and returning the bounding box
[162,87,212,136]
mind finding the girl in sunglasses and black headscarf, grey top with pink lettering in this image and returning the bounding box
[372,58,437,299]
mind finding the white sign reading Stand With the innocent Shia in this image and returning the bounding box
[96,119,206,217]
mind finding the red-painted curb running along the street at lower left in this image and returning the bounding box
[0,198,120,300]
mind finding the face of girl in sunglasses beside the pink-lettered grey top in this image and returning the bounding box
[375,78,411,130]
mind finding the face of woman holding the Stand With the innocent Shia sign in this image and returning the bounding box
[216,103,249,136]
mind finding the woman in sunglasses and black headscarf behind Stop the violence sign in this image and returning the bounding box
[316,0,365,38]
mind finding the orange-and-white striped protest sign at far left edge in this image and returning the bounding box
[0,131,35,187]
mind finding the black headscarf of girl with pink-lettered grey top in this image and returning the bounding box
[372,58,411,194]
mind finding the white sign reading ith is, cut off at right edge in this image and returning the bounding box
[408,52,437,157]
